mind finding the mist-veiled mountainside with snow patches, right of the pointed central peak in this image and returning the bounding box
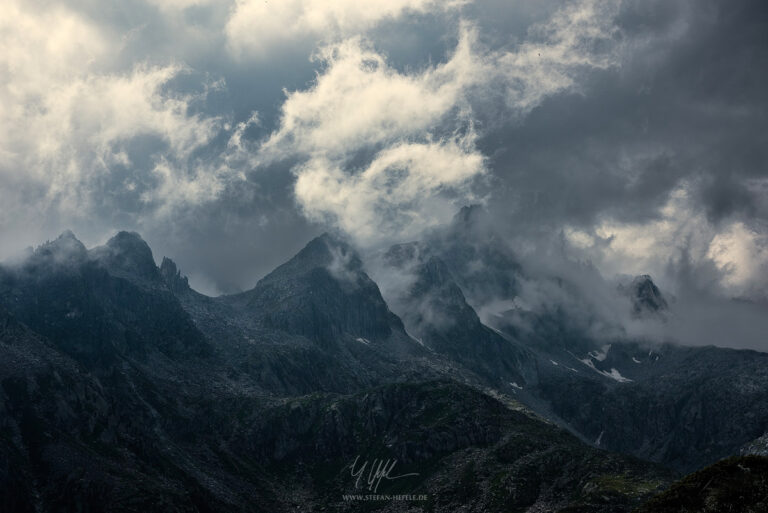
[396,207,768,472]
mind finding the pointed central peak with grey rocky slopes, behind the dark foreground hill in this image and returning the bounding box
[161,235,437,396]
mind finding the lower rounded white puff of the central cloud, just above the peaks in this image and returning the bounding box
[295,137,485,244]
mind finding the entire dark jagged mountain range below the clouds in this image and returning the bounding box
[0,207,768,513]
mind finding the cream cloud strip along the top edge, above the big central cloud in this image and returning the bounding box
[225,0,466,57]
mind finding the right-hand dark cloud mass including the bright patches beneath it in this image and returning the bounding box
[486,0,768,304]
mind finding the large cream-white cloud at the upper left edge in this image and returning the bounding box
[0,0,244,244]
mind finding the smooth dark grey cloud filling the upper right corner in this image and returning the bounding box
[484,2,768,230]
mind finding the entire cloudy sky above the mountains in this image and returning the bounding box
[0,0,768,312]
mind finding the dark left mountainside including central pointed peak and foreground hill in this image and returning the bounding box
[0,234,680,512]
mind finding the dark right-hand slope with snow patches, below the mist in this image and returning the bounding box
[488,280,768,472]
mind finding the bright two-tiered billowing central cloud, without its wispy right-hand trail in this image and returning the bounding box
[261,29,486,244]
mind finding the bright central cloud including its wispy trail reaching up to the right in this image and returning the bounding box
[261,1,617,248]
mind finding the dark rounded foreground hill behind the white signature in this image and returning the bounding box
[238,381,668,512]
